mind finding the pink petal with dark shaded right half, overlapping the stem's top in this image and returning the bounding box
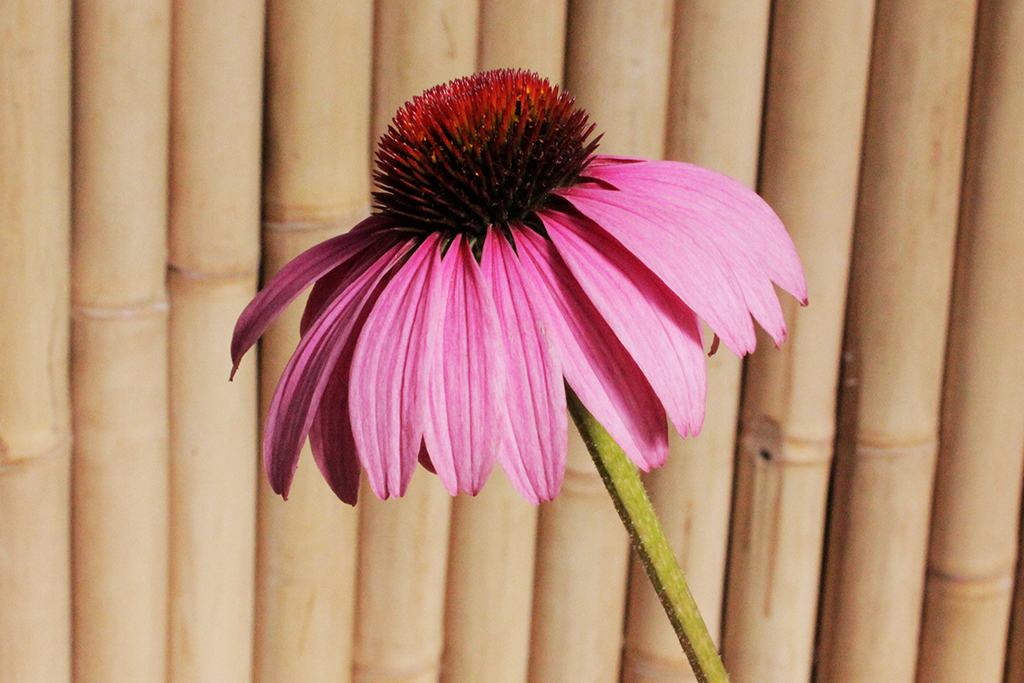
[512,226,669,471]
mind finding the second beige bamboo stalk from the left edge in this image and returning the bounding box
[72,0,171,683]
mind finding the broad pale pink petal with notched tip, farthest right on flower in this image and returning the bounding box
[558,159,807,353]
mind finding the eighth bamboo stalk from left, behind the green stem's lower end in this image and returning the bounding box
[623,0,768,683]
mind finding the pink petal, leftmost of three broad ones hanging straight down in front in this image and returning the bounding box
[348,233,443,500]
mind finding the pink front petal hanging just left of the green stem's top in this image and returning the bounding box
[480,230,568,505]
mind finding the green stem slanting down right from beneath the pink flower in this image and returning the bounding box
[565,386,729,683]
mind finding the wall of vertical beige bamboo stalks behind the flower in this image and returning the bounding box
[0,0,1024,683]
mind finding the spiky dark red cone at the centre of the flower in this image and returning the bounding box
[373,69,599,236]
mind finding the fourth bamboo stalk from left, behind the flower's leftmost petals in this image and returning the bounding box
[255,0,373,683]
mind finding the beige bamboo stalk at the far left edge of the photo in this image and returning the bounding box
[0,0,71,682]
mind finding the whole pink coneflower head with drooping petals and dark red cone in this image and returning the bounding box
[231,70,807,504]
